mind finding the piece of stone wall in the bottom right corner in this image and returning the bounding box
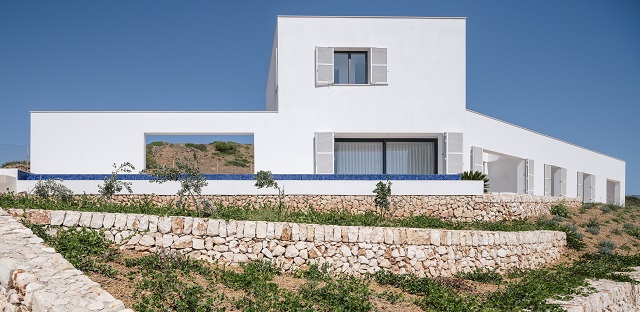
[548,267,640,312]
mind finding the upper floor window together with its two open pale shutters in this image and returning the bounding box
[316,47,388,86]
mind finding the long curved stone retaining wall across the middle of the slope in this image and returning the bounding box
[9,209,566,277]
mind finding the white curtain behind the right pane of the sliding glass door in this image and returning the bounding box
[387,142,435,174]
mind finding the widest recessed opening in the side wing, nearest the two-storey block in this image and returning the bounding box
[482,150,526,194]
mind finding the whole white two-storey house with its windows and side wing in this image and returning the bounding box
[26,16,625,202]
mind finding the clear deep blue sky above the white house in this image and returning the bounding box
[0,0,640,194]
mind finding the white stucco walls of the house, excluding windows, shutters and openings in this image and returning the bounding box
[31,17,625,202]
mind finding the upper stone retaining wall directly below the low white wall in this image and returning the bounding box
[102,194,582,222]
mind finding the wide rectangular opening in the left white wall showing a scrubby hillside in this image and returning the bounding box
[145,134,254,174]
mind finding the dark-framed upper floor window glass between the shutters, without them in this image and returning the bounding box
[333,51,369,84]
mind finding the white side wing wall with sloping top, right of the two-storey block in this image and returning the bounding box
[464,111,625,202]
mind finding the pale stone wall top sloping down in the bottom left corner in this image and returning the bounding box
[0,209,132,312]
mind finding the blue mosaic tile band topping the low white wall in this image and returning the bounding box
[18,171,460,181]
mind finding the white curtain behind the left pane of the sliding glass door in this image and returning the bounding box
[334,142,382,174]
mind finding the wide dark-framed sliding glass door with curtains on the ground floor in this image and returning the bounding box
[334,139,437,174]
